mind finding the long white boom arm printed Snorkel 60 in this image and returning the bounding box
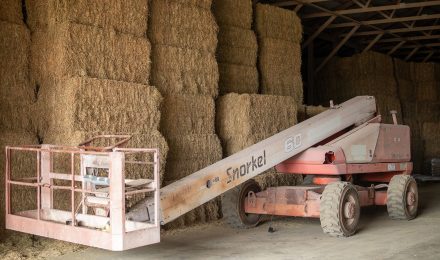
[160,96,376,224]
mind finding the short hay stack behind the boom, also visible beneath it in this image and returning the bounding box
[216,93,297,188]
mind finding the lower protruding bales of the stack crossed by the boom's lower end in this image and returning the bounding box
[161,95,223,228]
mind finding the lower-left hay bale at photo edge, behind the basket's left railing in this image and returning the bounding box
[0,130,38,233]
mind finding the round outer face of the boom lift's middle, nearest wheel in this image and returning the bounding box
[339,187,360,235]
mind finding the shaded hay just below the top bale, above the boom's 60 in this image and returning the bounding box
[258,38,303,102]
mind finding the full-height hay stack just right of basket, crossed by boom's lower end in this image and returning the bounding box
[148,0,222,228]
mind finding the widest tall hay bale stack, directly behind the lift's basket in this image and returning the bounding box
[26,0,168,207]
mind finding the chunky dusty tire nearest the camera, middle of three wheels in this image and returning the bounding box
[319,181,361,237]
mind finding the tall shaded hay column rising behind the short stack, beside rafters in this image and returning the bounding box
[255,4,303,103]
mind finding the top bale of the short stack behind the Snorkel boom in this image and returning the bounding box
[216,93,297,142]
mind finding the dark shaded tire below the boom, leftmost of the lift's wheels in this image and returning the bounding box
[222,180,262,228]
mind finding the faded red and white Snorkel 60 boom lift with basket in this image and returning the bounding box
[6,96,418,250]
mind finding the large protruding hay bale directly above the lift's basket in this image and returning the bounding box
[38,77,162,135]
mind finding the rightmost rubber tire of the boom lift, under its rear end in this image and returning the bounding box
[387,174,418,220]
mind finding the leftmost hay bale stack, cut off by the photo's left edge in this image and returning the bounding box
[0,4,38,236]
